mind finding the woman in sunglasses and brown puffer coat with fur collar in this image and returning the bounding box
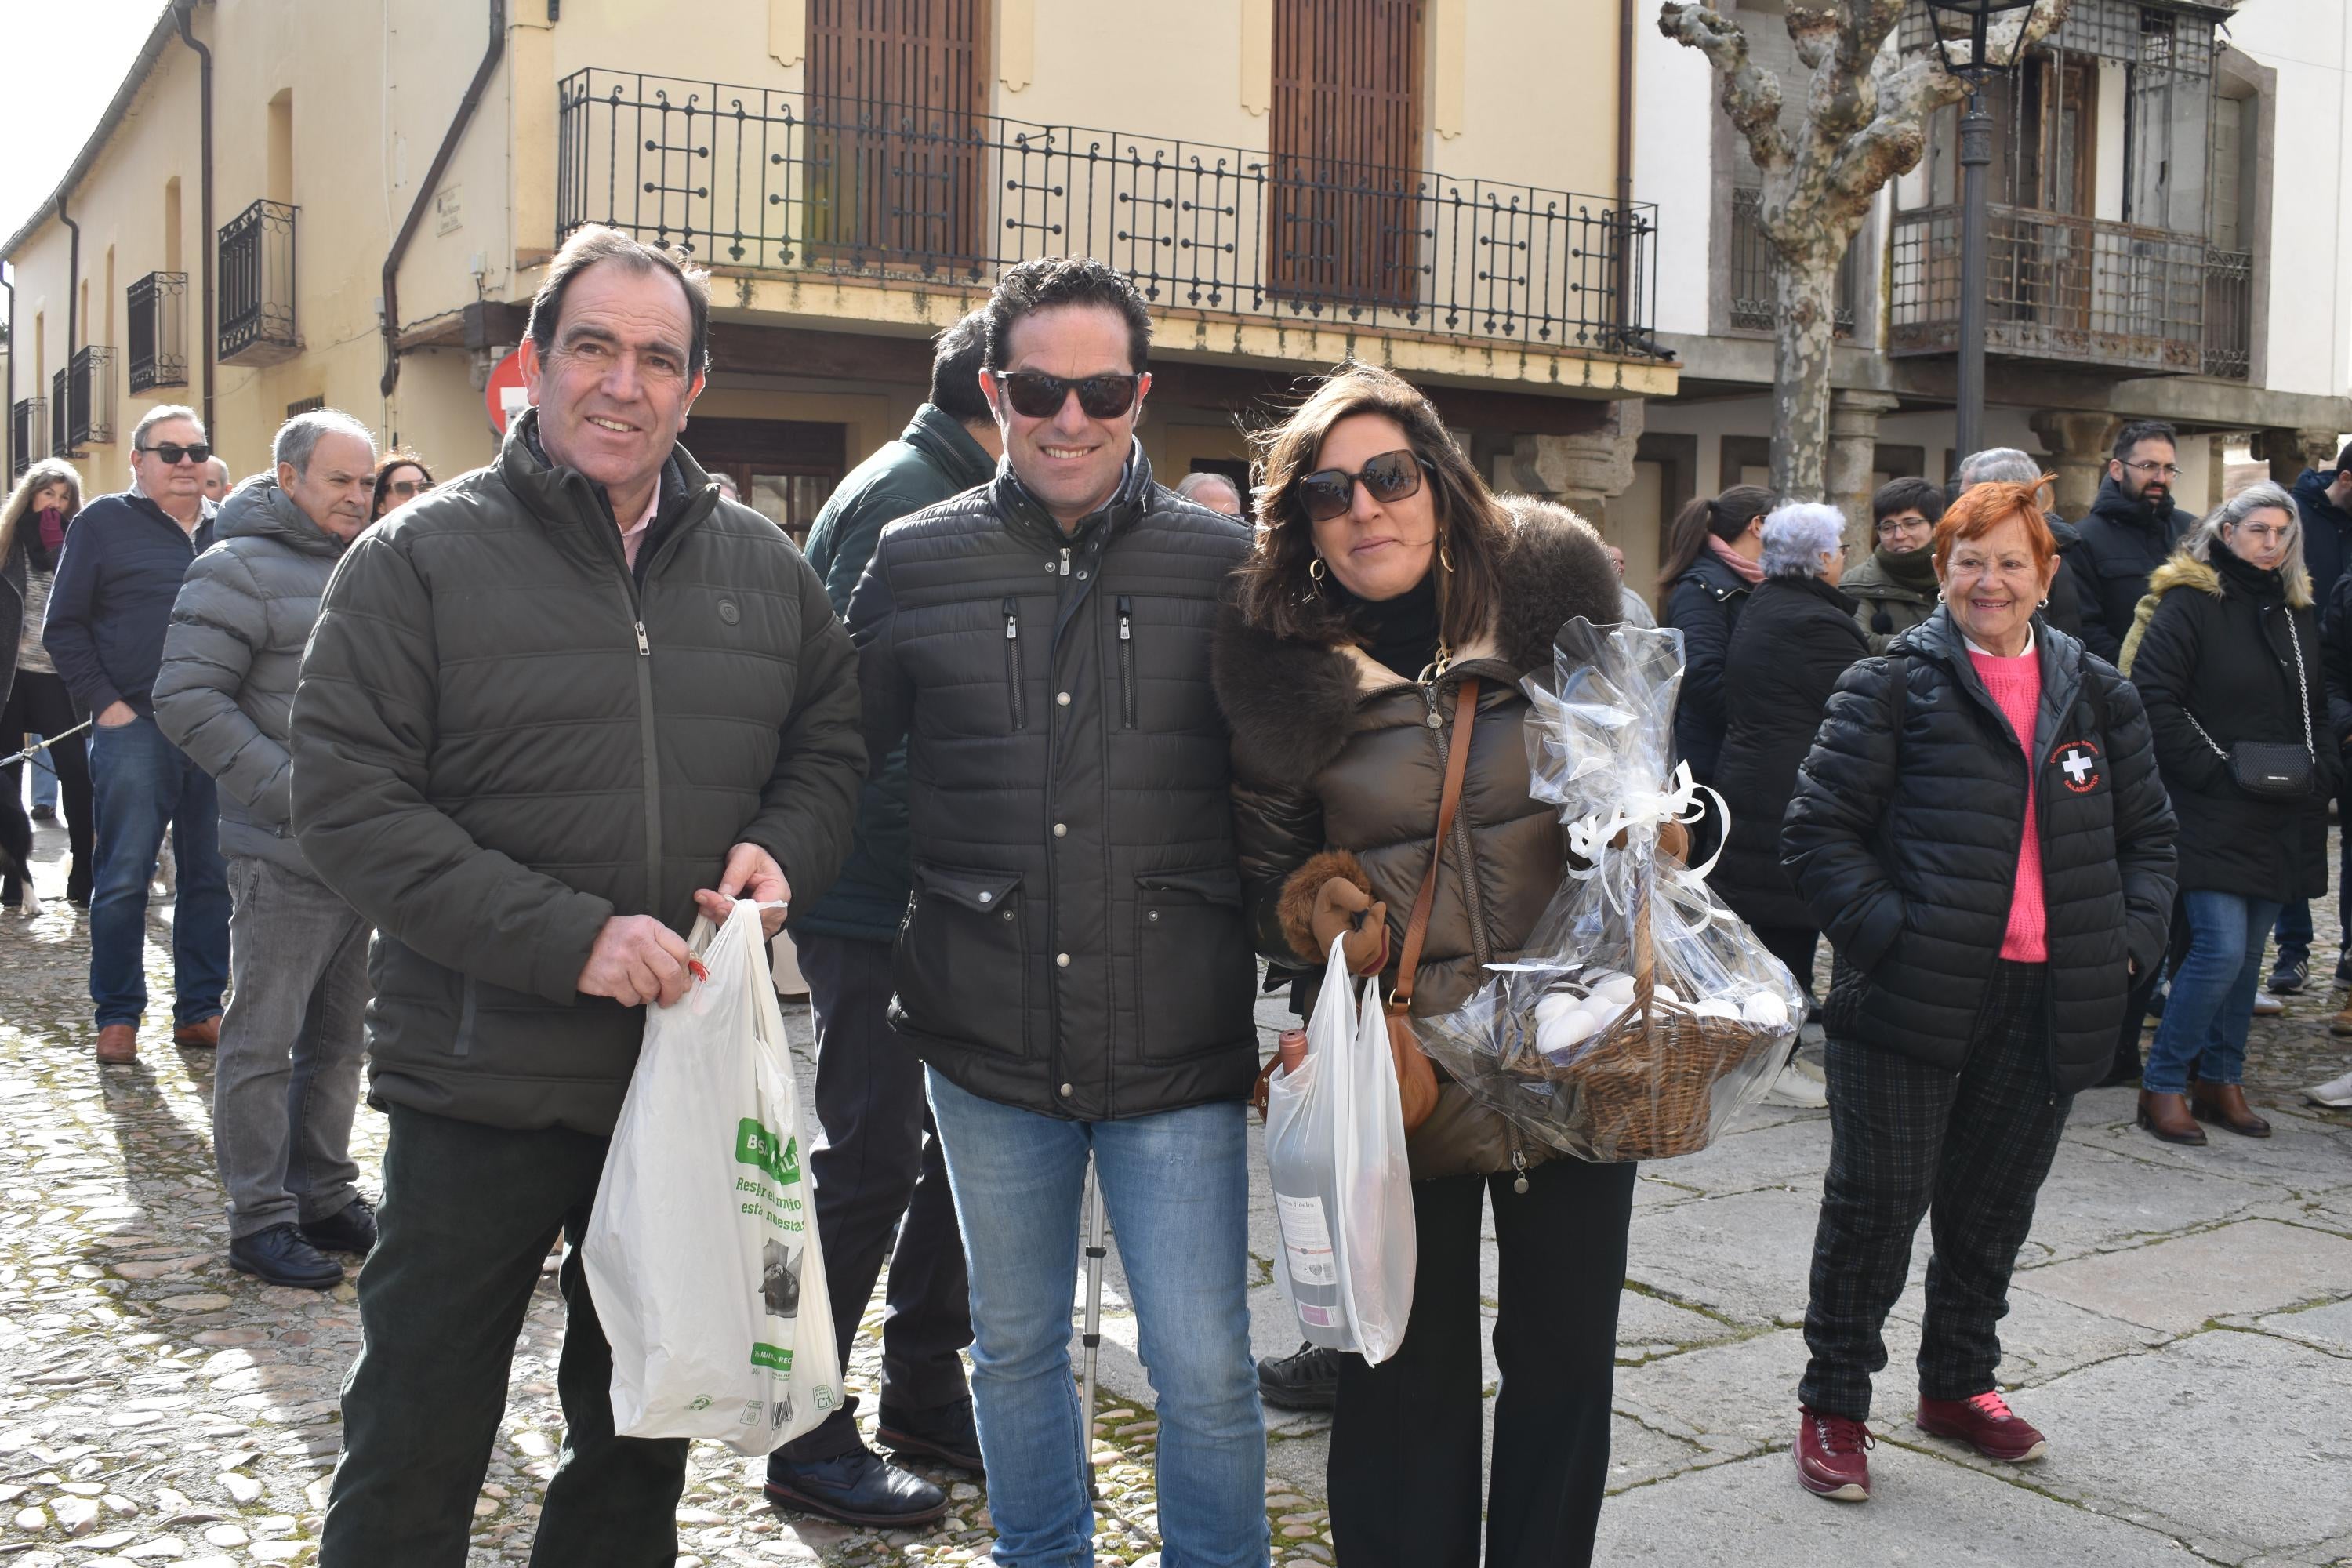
[1214,365,1635,1568]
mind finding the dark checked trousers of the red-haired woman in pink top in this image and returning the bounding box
[1797,961,2074,1420]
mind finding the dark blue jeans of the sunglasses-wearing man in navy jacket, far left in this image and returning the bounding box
[89,715,228,1029]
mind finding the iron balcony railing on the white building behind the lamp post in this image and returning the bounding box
[1889,207,2251,376]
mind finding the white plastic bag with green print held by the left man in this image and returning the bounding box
[581,900,842,1453]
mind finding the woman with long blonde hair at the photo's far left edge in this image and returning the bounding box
[0,459,92,909]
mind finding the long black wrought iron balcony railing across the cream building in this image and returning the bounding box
[555,68,1663,358]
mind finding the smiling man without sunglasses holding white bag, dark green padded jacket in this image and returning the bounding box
[292,228,866,1568]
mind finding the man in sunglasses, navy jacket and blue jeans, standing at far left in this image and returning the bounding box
[42,405,228,1062]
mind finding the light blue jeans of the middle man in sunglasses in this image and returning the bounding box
[927,1072,1268,1568]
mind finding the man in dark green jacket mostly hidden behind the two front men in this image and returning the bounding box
[767,310,1004,1526]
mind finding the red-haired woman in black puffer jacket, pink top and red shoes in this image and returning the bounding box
[1780,485,2173,1500]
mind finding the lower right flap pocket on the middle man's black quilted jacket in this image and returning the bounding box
[1136,867,1256,1060]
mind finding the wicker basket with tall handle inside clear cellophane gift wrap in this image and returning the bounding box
[1510,879,1795,1159]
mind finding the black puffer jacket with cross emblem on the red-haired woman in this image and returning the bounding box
[1780,607,2176,1093]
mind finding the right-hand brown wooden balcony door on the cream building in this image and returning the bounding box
[1268,0,1428,306]
